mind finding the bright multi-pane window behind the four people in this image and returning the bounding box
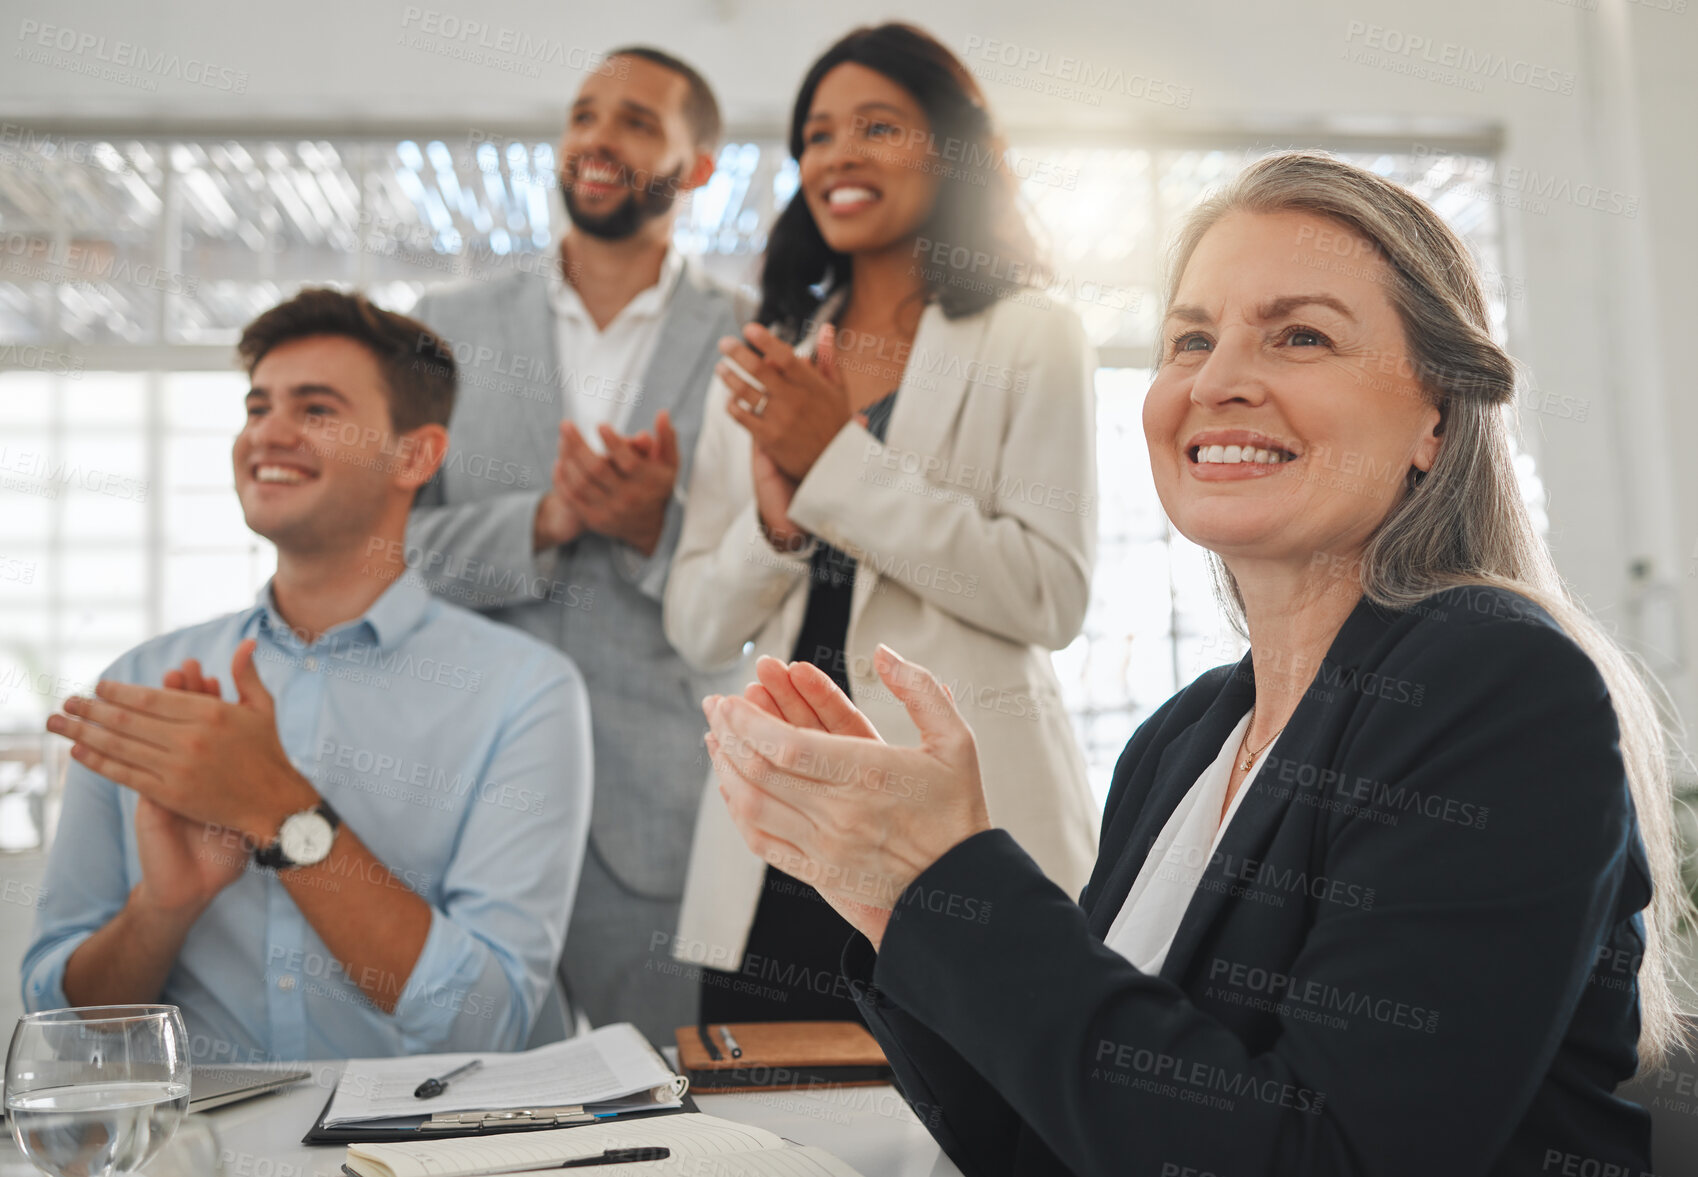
[0,132,1540,798]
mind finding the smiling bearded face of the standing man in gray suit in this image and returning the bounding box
[559,58,713,241]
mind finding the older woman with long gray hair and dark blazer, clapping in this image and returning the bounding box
[705,155,1686,1177]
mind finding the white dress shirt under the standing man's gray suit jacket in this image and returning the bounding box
[548,246,684,453]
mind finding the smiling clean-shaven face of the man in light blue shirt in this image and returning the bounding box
[231,335,445,555]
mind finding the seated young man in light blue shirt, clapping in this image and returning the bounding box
[22,290,593,1062]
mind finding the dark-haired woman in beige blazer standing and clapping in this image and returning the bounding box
[666,24,1097,1021]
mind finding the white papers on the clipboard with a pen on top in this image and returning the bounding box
[324,1022,678,1126]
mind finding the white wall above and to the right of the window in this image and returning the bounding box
[0,0,1698,727]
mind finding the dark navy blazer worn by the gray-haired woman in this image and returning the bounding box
[844,588,1650,1177]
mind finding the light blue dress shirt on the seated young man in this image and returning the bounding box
[22,574,593,1062]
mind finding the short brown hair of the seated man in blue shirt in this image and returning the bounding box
[236,287,457,433]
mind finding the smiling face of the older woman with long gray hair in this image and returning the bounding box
[1143,212,1440,579]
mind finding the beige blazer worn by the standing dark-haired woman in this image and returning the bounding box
[664,292,1099,970]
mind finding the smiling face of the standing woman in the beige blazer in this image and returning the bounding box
[798,63,941,253]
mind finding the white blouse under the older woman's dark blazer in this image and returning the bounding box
[1104,712,1279,973]
